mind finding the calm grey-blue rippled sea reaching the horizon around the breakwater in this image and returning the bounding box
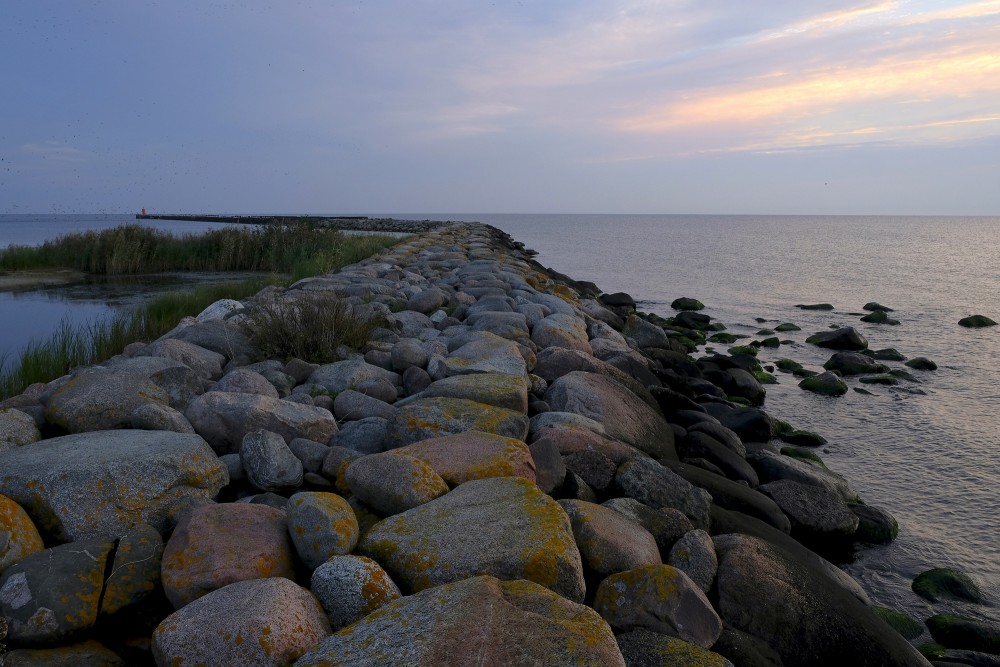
[0,213,1000,639]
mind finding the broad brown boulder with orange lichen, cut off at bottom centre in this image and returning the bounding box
[295,576,625,667]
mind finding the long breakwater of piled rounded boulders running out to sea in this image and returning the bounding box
[0,224,929,667]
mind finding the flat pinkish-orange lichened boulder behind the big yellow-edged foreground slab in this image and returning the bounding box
[392,431,535,487]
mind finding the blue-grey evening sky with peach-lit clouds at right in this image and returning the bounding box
[0,0,1000,215]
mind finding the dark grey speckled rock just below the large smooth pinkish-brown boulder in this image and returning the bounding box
[615,458,712,528]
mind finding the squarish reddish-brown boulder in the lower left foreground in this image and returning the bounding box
[162,503,295,609]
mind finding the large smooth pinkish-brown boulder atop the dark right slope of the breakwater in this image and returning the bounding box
[545,371,677,460]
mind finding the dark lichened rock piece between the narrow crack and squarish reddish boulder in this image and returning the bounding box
[101,524,163,615]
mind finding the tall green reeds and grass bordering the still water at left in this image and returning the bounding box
[0,225,399,399]
